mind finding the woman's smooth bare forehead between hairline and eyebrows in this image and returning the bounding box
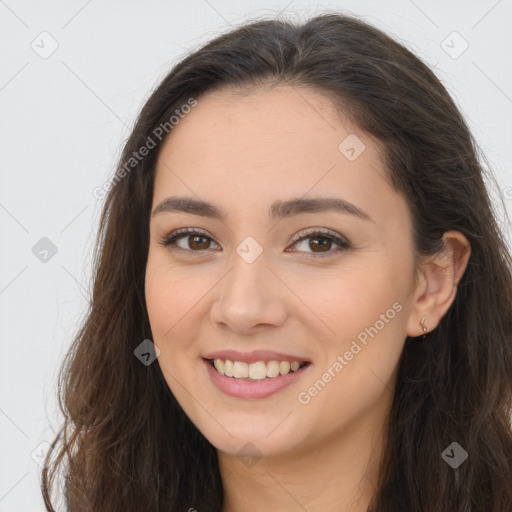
[154,86,396,220]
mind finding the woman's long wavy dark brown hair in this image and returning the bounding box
[41,13,512,512]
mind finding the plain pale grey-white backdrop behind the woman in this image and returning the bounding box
[0,0,512,512]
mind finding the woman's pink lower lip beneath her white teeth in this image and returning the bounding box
[203,359,312,398]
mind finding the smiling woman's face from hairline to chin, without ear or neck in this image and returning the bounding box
[146,86,420,456]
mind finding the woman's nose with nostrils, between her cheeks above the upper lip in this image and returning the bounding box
[211,254,289,334]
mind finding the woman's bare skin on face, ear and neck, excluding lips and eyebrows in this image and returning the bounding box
[146,86,470,512]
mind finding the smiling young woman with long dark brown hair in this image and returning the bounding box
[42,14,512,512]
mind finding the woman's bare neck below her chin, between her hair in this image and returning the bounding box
[218,394,390,512]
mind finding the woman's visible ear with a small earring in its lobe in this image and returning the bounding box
[406,231,471,337]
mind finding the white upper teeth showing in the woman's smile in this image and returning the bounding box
[213,359,306,380]
